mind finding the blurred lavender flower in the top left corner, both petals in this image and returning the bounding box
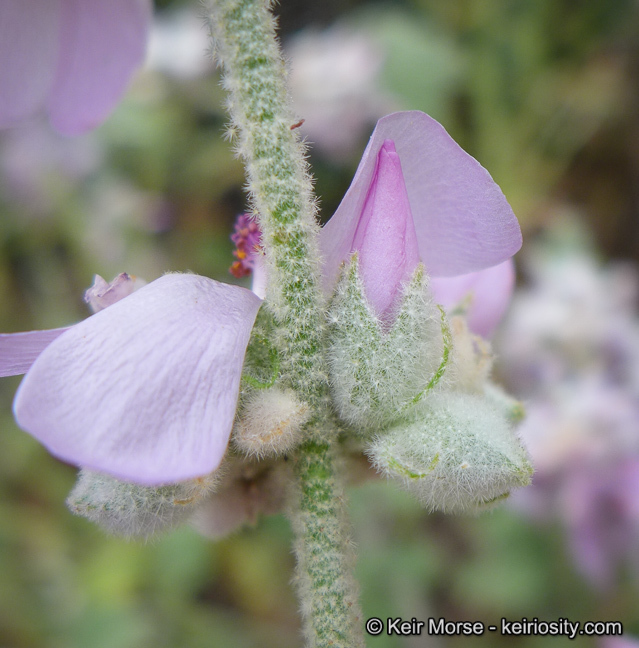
[0,0,151,135]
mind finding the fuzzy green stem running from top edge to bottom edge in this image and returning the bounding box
[211,0,364,648]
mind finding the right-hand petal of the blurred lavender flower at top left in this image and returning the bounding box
[46,0,151,135]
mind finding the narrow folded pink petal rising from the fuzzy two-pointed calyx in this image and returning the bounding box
[352,140,419,317]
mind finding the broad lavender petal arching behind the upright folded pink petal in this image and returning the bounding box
[320,111,521,292]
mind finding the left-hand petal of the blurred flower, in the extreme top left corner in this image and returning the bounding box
[0,0,61,128]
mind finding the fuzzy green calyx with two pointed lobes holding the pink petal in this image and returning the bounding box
[327,254,452,434]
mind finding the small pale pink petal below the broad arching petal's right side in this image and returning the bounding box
[430,259,515,338]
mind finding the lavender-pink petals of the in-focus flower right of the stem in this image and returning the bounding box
[320,111,521,333]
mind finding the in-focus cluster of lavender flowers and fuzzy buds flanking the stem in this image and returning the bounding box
[0,112,531,535]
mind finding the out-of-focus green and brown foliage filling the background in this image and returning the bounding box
[0,0,639,648]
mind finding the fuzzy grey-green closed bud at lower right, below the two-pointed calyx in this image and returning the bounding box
[368,393,532,513]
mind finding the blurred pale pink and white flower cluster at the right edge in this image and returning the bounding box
[499,215,639,586]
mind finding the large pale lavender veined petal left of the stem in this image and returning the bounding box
[14,274,261,486]
